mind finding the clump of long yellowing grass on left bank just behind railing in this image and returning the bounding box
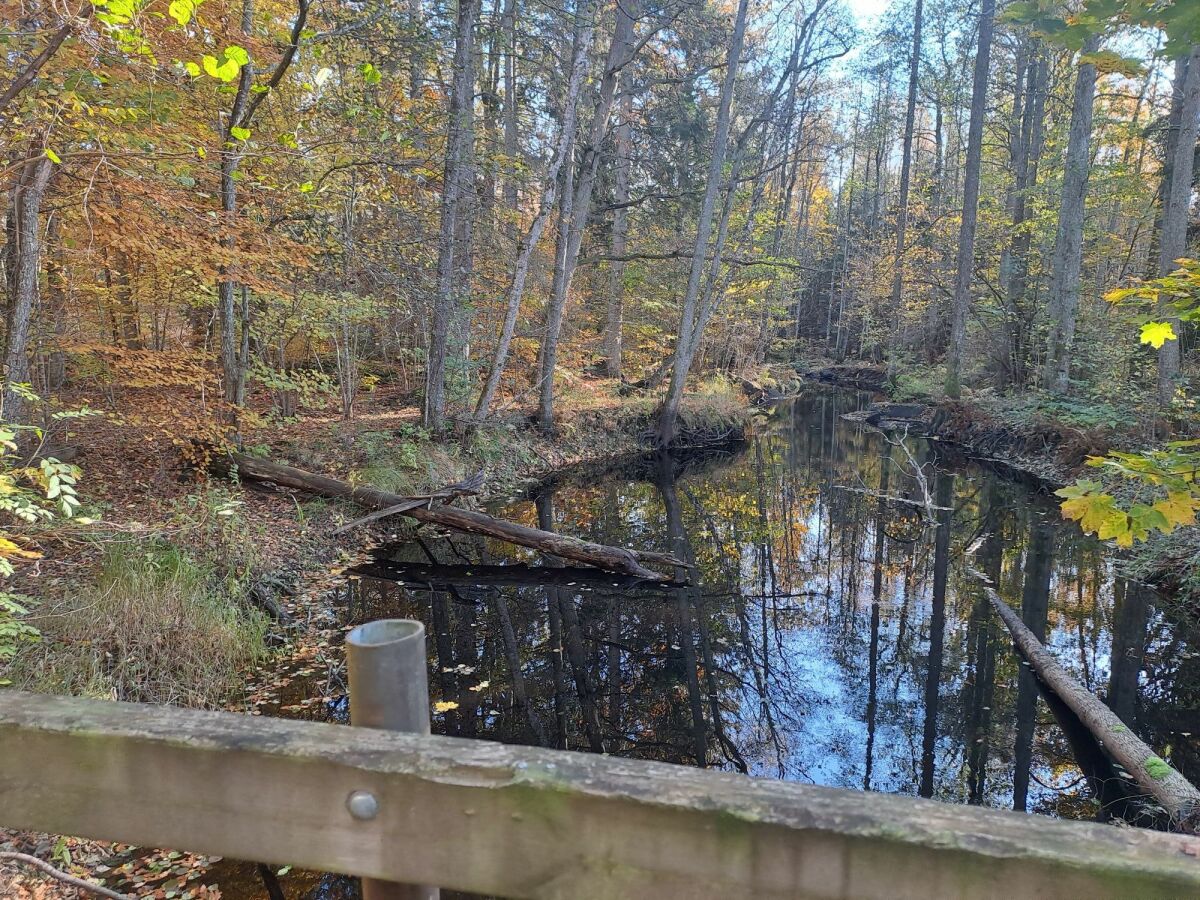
[6,486,268,708]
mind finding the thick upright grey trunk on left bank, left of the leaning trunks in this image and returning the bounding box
[425,0,480,433]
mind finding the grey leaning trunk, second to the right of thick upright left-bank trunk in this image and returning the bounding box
[538,0,637,428]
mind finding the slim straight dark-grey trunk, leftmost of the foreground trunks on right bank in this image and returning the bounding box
[946,0,996,397]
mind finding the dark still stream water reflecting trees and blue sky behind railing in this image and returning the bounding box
[211,391,1200,897]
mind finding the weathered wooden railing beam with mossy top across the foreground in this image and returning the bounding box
[0,692,1200,900]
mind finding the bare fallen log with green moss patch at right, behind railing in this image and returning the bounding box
[967,566,1200,834]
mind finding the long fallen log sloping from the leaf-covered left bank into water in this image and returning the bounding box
[228,454,686,582]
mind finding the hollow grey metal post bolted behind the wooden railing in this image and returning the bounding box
[346,619,439,900]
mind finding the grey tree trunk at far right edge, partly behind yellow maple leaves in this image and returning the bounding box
[1158,43,1200,406]
